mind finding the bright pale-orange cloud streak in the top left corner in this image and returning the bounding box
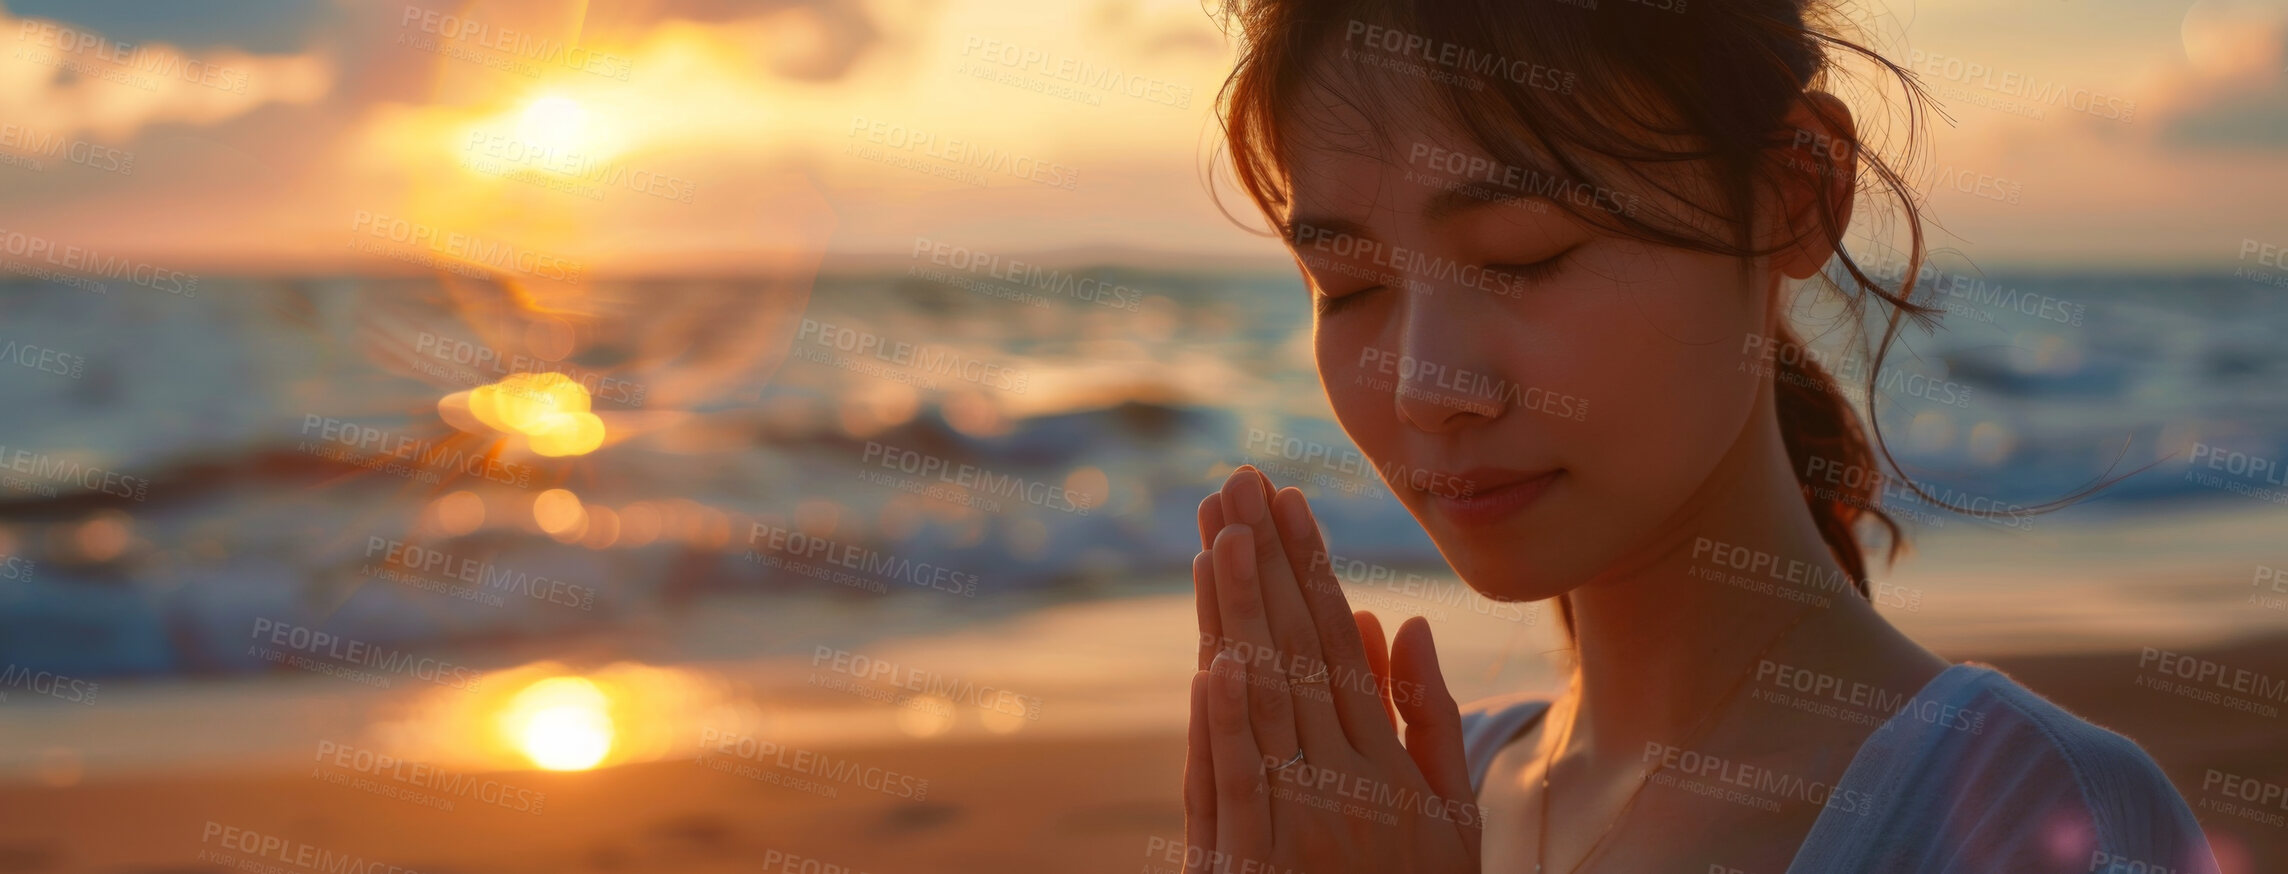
[0,11,334,140]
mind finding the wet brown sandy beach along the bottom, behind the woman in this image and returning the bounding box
[0,629,2288,874]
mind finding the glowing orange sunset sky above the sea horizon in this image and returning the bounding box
[0,0,2288,279]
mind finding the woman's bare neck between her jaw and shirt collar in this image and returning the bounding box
[1565,391,1881,766]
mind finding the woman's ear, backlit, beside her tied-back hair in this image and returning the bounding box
[1769,92,1858,279]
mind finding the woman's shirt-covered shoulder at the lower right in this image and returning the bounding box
[1802,664,2215,874]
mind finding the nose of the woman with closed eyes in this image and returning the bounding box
[1393,293,1517,435]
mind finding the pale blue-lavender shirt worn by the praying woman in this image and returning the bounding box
[1462,664,2217,874]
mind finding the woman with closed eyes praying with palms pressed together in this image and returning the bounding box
[1185,0,2215,874]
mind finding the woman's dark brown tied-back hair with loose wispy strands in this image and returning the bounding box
[1217,0,1945,627]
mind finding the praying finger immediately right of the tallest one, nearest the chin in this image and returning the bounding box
[1277,487,1398,755]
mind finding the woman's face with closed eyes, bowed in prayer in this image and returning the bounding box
[1288,100,1775,599]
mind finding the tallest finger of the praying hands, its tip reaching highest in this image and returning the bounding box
[1222,467,1364,762]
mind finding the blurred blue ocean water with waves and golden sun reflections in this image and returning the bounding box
[0,268,2288,677]
